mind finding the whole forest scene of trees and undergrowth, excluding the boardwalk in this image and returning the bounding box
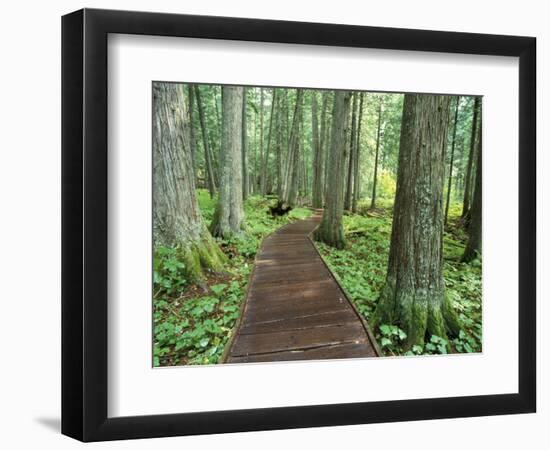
[153,83,482,365]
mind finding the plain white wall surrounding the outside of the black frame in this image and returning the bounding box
[0,0,550,450]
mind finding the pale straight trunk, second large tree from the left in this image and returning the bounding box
[210,86,244,238]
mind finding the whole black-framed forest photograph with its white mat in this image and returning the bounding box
[62,9,536,441]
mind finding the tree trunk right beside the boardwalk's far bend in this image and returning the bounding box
[314,91,351,248]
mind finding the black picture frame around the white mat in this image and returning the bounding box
[62,9,536,441]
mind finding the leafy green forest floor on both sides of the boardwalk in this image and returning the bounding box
[153,190,482,366]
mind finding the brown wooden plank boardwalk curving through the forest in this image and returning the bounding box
[222,211,378,363]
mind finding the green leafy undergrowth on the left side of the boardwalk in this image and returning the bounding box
[153,189,311,366]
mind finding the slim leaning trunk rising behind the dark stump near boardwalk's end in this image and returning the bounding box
[279,89,304,209]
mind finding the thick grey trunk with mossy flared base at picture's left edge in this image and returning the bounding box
[153,83,225,282]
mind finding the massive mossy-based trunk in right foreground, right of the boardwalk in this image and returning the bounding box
[372,94,460,348]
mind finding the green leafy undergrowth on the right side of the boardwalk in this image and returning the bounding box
[316,203,482,356]
